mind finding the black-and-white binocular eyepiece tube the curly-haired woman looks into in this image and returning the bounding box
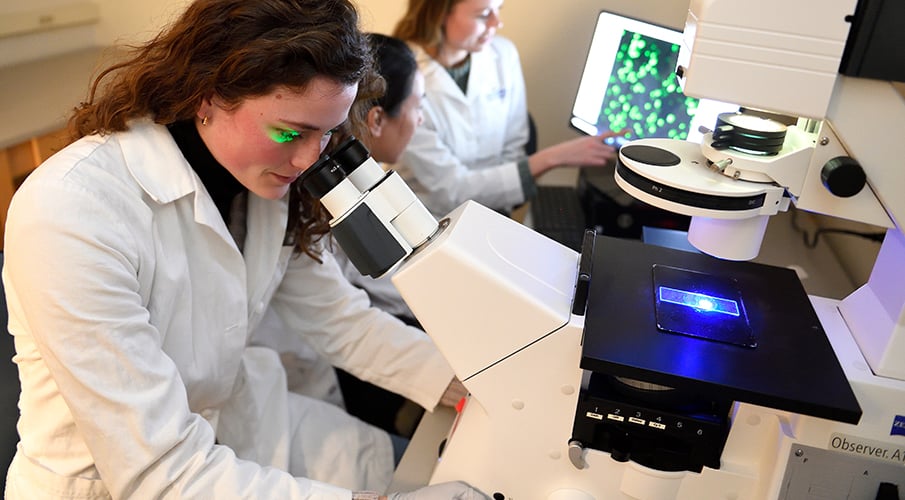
[299,137,439,278]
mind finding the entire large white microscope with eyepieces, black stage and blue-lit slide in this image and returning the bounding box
[301,0,905,500]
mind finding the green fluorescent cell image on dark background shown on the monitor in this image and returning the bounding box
[598,32,698,140]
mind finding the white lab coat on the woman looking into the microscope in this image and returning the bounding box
[3,121,453,500]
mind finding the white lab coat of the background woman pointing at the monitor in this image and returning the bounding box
[393,36,528,217]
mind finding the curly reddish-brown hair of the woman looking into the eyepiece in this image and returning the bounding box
[69,0,383,258]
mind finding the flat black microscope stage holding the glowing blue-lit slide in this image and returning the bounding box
[581,236,861,423]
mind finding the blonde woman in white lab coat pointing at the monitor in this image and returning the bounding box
[394,0,618,217]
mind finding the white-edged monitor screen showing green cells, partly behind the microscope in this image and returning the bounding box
[571,12,738,145]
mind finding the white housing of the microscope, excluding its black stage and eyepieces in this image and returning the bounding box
[382,0,905,500]
